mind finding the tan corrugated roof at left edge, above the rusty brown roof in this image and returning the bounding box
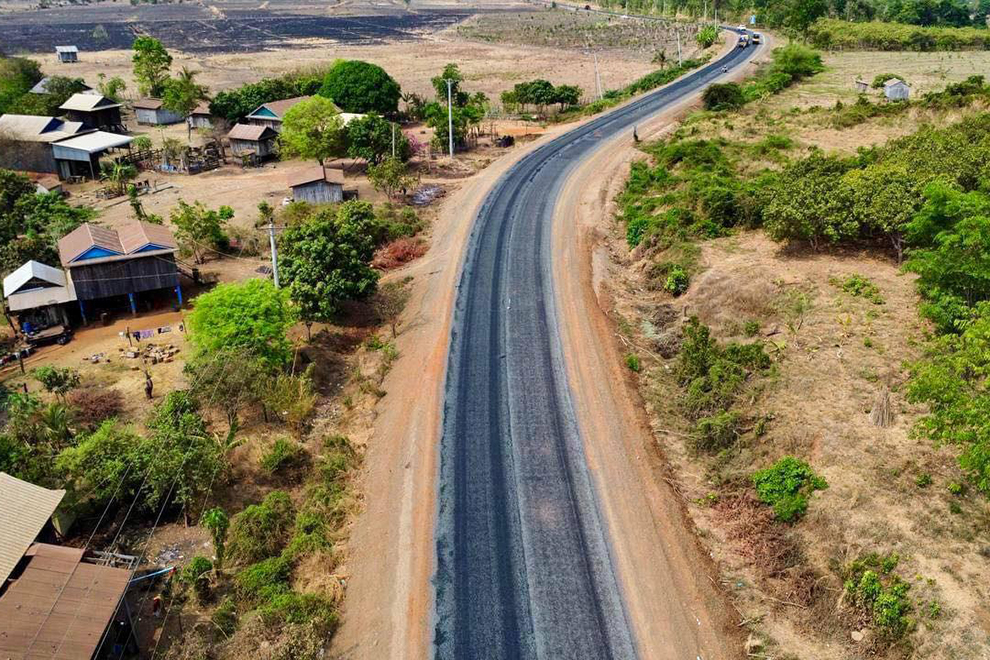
[0,472,65,584]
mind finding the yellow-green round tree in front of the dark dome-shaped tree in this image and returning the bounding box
[279,96,347,166]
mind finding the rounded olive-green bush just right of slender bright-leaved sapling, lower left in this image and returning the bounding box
[227,490,293,563]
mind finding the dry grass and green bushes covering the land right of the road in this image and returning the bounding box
[615,37,990,658]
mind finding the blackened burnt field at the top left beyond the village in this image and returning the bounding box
[0,3,484,55]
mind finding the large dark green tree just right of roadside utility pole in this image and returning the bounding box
[279,202,378,333]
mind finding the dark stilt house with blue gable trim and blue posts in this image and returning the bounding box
[58,221,182,322]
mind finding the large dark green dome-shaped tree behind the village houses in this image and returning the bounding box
[320,60,402,115]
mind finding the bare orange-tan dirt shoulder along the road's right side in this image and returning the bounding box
[553,40,768,660]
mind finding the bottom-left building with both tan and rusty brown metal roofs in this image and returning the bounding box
[0,472,137,660]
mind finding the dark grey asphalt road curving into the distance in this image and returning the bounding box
[433,32,755,660]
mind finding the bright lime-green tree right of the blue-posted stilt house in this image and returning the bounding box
[188,279,298,368]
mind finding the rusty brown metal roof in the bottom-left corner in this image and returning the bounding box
[0,543,131,660]
